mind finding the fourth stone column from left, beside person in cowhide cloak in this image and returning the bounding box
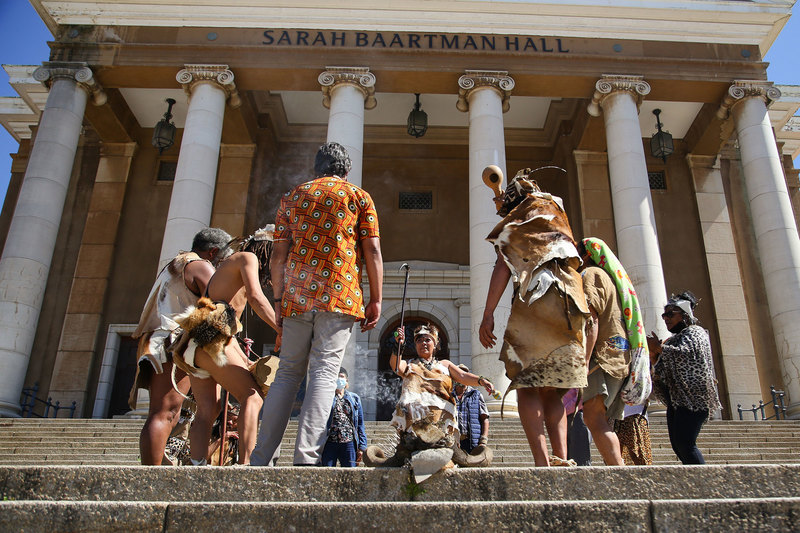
[456,70,516,411]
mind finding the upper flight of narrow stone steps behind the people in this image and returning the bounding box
[0,416,800,467]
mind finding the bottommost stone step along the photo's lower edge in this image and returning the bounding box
[0,498,800,533]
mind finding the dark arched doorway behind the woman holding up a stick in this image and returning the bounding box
[375,317,450,420]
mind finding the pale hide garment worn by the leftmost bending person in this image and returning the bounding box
[128,252,204,409]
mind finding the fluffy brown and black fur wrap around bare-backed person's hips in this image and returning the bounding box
[169,297,242,378]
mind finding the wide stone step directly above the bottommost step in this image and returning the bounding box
[0,465,800,502]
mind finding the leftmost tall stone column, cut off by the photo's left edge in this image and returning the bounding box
[0,62,105,416]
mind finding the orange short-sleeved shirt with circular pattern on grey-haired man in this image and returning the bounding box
[275,176,379,319]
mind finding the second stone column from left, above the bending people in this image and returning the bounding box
[158,65,241,269]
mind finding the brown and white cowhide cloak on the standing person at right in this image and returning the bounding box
[486,192,589,390]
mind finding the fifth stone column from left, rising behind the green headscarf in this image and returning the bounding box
[588,75,669,338]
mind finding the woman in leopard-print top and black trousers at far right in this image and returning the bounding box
[647,291,722,465]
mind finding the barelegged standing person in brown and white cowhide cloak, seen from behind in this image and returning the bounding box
[479,169,589,466]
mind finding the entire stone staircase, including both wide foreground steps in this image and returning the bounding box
[0,417,800,533]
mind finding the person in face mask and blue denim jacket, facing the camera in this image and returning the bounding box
[321,368,367,466]
